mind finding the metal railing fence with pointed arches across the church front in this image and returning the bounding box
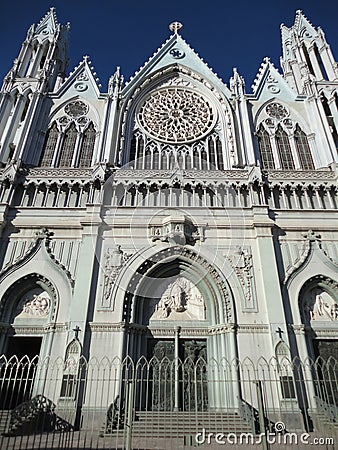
[0,356,338,450]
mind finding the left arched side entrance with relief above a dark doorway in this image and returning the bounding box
[0,273,56,409]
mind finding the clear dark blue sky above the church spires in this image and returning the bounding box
[0,0,338,91]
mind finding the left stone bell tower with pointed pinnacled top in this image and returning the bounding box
[0,8,69,165]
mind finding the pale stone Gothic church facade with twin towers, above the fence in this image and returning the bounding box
[0,8,338,414]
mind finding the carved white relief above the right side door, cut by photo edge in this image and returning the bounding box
[304,287,338,323]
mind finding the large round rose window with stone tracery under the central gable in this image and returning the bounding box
[136,88,216,143]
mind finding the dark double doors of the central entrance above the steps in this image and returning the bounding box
[148,338,208,411]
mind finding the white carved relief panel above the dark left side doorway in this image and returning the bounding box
[15,288,51,319]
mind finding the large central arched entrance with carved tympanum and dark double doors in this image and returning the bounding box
[120,245,239,410]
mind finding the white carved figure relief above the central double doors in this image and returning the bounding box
[150,277,205,320]
